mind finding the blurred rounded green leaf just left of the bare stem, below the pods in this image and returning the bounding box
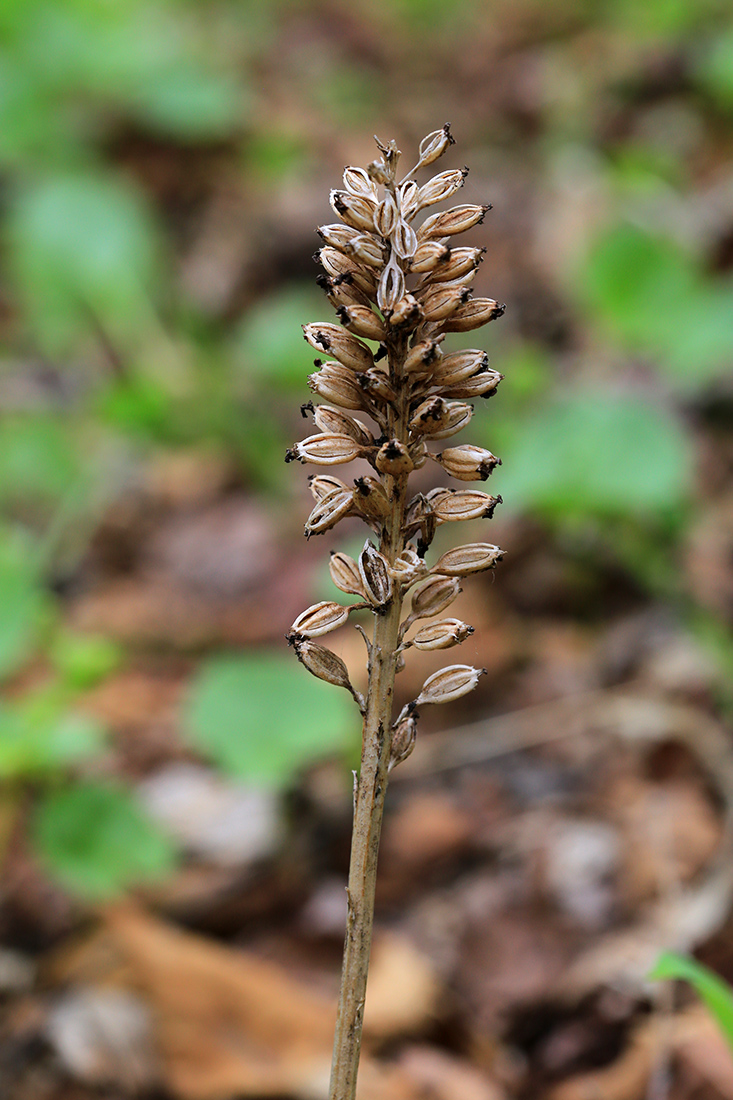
[186,655,354,787]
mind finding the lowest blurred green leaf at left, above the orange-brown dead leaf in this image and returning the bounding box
[33,782,174,900]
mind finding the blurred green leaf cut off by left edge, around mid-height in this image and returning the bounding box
[0,528,51,680]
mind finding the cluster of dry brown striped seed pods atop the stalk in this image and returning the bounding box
[286,125,504,763]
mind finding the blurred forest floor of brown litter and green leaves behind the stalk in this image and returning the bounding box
[0,0,733,1100]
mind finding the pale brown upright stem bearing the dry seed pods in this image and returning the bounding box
[329,342,408,1100]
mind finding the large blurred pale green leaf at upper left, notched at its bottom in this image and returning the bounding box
[9,174,156,352]
